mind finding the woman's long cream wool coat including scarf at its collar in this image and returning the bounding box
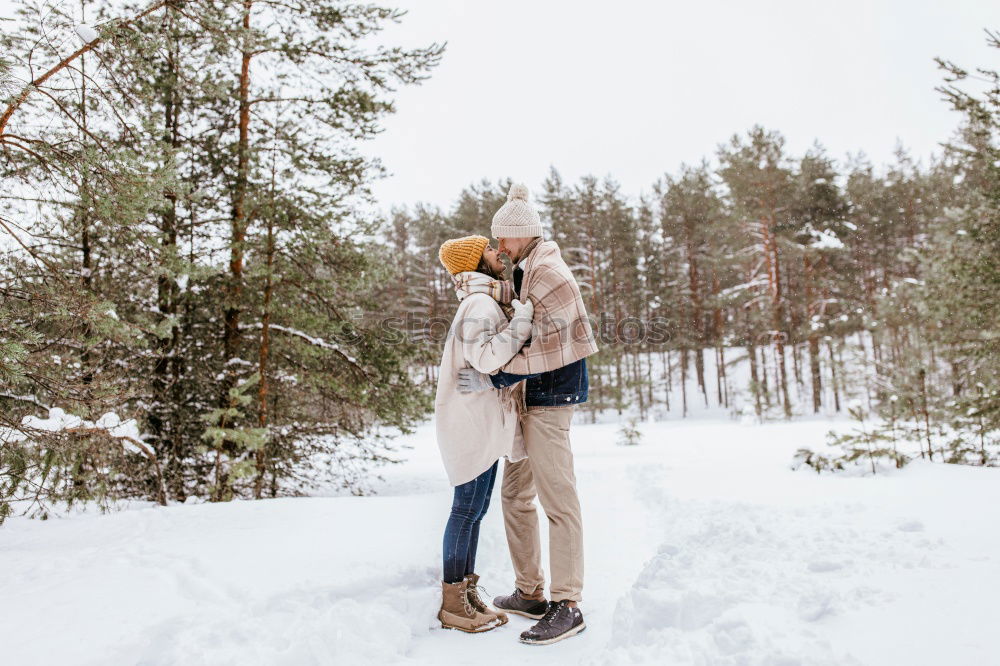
[434,272,525,486]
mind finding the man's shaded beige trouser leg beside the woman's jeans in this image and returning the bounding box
[500,459,545,599]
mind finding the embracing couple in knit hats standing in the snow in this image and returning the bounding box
[435,184,597,645]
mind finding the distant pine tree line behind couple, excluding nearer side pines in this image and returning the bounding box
[387,141,944,417]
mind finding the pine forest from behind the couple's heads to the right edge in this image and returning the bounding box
[386,33,1000,469]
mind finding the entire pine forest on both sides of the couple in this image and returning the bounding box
[0,0,1000,520]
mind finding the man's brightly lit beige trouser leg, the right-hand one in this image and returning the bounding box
[520,406,583,602]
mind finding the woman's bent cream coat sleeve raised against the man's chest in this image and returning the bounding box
[454,294,531,375]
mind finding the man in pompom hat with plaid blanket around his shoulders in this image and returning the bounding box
[459,184,597,645]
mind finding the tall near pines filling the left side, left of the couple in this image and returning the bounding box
[0,0,443,520]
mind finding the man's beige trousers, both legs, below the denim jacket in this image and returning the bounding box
[501,406,583,601]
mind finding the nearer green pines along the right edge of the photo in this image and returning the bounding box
[801,32,1000,473]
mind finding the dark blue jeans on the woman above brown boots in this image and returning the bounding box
[442,461,499,583]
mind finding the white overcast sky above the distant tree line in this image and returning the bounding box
[7,0,1000,207]
